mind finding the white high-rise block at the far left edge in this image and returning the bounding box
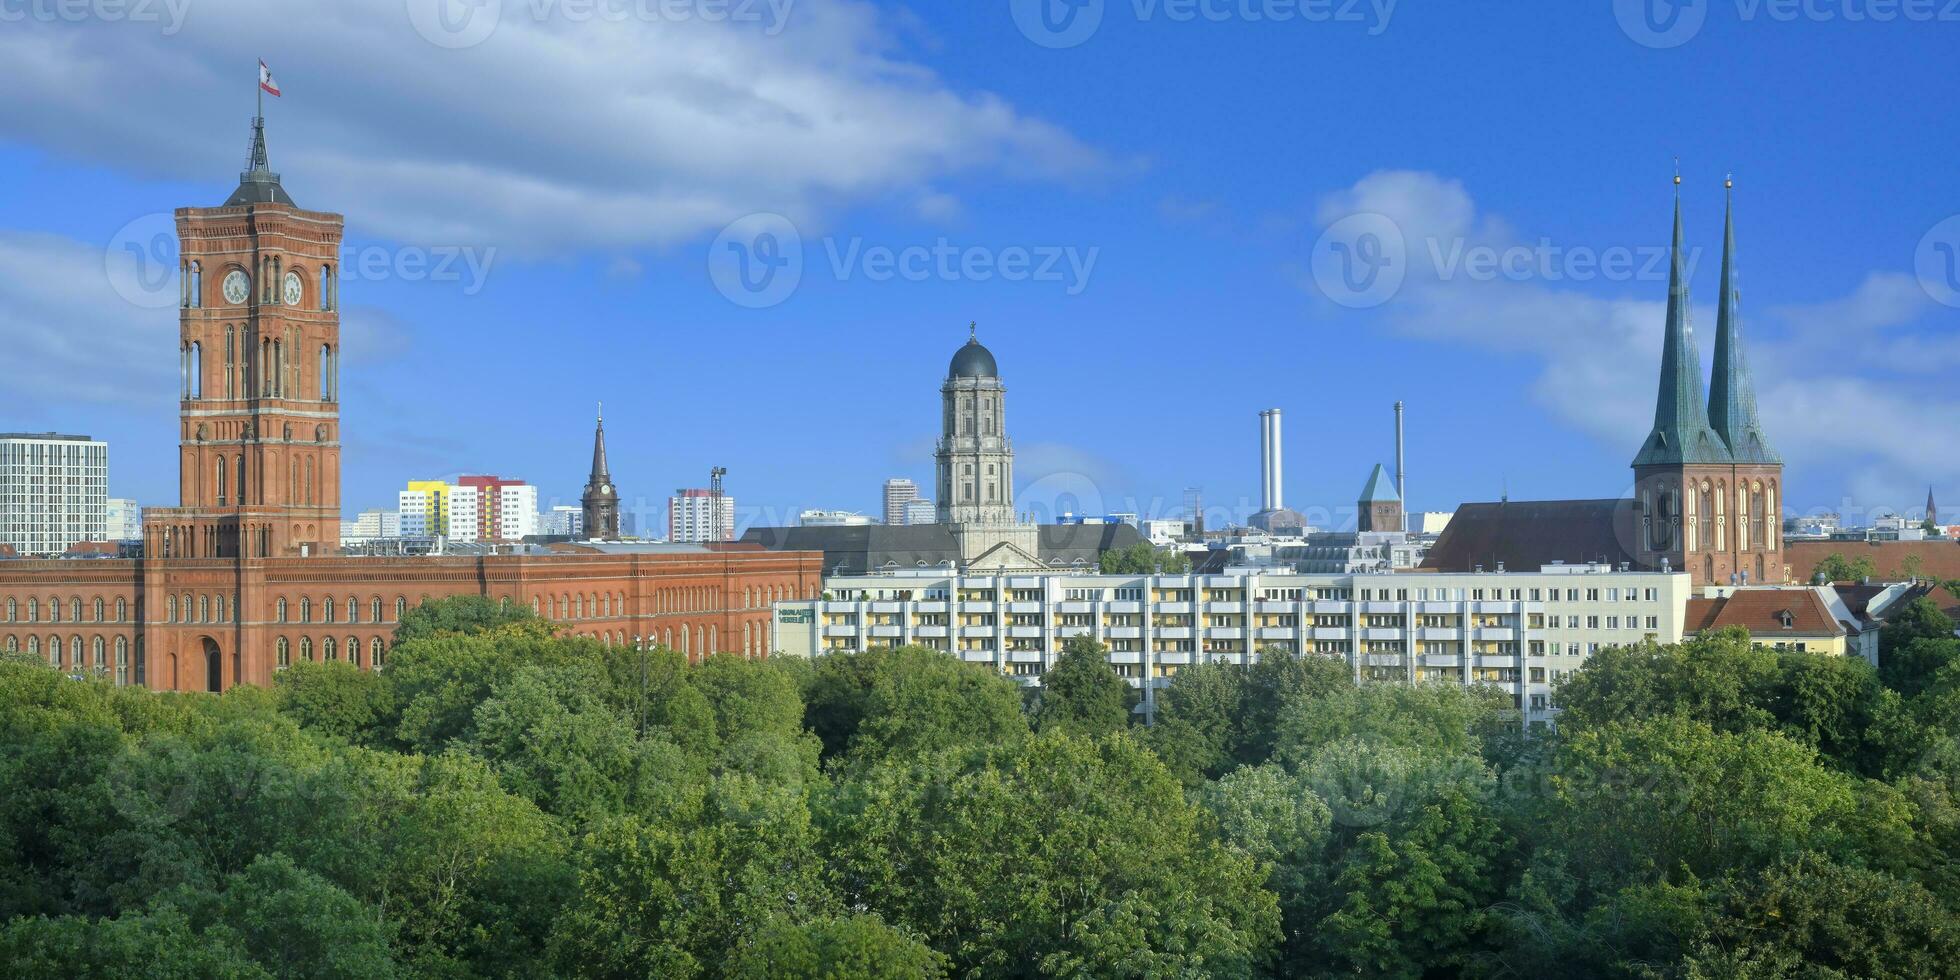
[0,433,108,555]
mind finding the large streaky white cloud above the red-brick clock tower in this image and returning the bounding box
[0,0,1100,253]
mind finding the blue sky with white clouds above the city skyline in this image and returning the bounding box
[0,0,1960,537]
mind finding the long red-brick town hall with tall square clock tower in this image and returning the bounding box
[0,112,823,692]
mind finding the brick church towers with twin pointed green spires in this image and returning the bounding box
[1633,178,1789,586]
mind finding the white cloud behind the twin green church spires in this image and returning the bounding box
[1317,171,1960,512]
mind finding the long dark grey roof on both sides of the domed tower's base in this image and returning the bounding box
[741,523,1143,574]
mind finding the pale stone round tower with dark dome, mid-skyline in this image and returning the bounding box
[933,327,1013,525]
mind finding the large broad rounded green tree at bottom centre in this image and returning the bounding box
[821,733,1278,976]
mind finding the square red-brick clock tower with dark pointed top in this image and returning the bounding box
[145,118,341,559]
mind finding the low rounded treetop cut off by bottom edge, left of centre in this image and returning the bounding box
[723,915,947,980]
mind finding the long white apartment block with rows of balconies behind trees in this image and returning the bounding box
[774,564,1691,723]
